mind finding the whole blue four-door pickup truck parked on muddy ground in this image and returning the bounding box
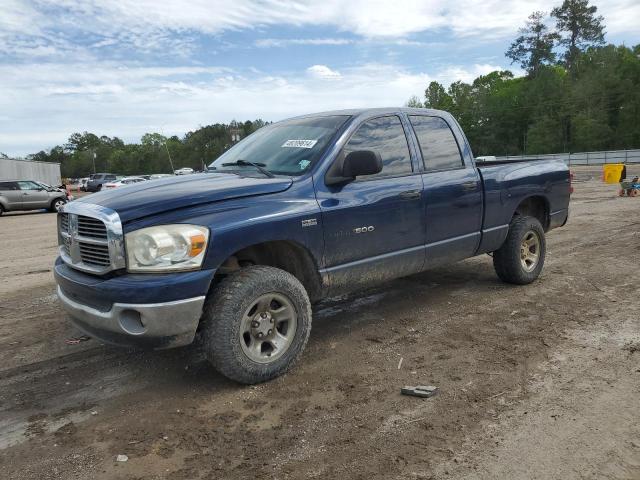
[55,109,571,383]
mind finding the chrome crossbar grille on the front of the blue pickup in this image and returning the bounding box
[58,202,125,274]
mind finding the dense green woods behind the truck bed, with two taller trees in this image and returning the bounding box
[407,0,640,155]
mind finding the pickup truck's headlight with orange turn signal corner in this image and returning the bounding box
[125,224,209,272]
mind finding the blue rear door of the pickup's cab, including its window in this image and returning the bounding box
[409,115,482,268]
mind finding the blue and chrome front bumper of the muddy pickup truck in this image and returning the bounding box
[54,260,214,349]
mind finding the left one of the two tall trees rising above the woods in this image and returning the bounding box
[505,12,560,76]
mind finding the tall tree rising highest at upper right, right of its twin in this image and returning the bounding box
[551,0,604,74]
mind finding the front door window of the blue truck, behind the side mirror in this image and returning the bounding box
[343,115,412,180]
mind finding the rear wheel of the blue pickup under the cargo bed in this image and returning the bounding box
[493,216,547,285]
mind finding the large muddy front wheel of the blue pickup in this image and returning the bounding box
[202,266,311,384]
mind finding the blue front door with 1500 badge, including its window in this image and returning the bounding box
[316,115,424,293]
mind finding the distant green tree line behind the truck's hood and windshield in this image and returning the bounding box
[27,120,266,178]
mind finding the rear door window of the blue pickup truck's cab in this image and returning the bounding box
[409,115,464,171]
